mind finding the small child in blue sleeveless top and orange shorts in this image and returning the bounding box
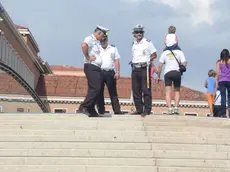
[205,69,216,116]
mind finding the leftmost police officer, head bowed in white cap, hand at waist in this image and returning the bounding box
[78,26,109,117]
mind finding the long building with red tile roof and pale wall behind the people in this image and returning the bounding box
[0,66,208,116]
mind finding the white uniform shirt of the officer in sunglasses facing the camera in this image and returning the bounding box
[132,38,157,63]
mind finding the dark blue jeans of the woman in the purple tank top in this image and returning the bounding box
[219,81,230,116]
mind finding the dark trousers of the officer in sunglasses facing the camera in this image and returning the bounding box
[132,67,152,114]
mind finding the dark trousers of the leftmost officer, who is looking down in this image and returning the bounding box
[81,64,101,112]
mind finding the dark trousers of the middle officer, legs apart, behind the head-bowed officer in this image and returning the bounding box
[97,70,121,114]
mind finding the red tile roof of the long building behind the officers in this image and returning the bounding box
[0,73,206,101]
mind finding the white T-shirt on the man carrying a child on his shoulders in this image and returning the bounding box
[159,50,186,75]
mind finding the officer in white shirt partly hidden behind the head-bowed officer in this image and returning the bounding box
[97,35,122,114]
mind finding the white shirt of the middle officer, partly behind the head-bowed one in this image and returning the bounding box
[100,45,120,70]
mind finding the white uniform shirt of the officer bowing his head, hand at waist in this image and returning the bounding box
[84,34,102,67]
